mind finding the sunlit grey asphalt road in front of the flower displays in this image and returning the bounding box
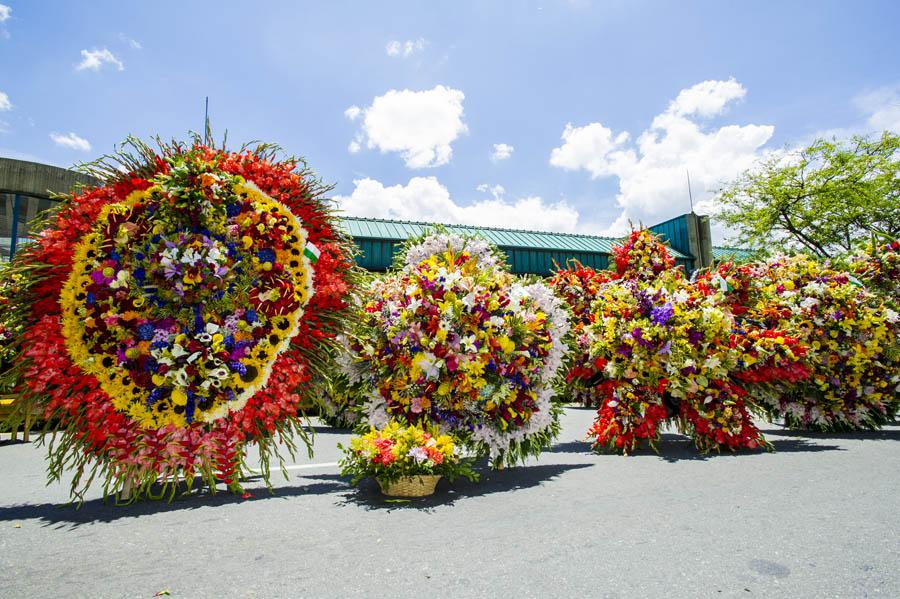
[0,409,900,598]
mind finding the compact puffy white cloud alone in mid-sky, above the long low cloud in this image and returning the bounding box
[344,85,468,168]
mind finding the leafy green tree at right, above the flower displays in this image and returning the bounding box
[716,131,900,257]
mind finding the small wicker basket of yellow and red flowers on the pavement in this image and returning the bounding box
[339,419,478,497]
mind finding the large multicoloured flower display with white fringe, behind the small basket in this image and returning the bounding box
[342,230,569,465]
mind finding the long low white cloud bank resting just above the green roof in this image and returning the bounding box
[335,177,578,232]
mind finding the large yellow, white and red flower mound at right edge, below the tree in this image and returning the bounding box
[718,256,900,430]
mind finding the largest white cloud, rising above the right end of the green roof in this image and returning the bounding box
[550,79,775,235]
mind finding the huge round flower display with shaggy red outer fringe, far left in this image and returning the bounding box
[2,140,353,497]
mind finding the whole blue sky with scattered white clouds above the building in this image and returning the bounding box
[0,0,900,241]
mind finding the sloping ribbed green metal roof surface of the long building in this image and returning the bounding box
[341,216,687,259]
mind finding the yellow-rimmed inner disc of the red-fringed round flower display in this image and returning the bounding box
[61,169,312,428]
